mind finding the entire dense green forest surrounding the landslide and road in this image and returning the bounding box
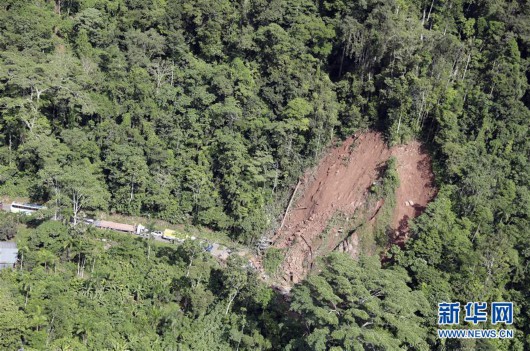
[0,0,530,350]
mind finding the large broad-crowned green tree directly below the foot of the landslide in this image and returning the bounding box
[291,254,430,350]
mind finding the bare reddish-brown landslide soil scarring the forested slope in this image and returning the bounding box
[273,132,435,283]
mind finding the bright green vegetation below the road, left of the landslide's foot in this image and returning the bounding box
[0,221,278,350]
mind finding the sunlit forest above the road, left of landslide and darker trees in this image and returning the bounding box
[0,0,337,241]
